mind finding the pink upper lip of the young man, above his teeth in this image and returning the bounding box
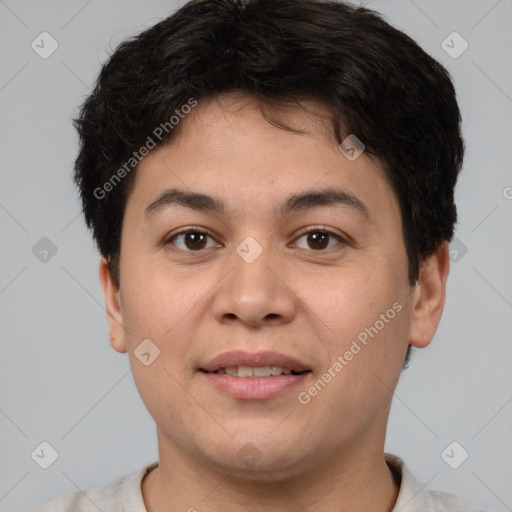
[200,350,309,372]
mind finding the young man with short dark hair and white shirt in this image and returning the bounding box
[33,0,480,512]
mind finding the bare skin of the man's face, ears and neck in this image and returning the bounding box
[100,93,449,512]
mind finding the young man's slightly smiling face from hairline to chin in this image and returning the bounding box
[100,94,448,478]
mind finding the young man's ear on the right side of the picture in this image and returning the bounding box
[409,241,450,348]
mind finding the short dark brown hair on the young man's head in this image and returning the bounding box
[74,0,464,296]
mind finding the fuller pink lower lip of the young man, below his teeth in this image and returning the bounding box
[201,372,310,400]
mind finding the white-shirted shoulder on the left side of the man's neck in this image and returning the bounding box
[30,463,157,512]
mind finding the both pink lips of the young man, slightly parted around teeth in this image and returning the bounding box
[199,350,311,400]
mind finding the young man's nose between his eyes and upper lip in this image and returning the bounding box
[212,239,298,327]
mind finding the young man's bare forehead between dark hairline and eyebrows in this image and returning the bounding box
[126,93,394,224]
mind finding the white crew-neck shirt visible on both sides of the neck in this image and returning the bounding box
[32,453,477,512]
